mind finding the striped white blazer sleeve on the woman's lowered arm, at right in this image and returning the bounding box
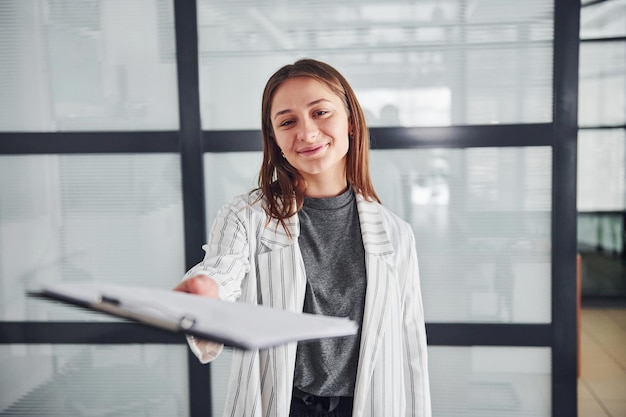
[403,226,432,417]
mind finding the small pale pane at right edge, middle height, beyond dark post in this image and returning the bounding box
[577,129,626,211]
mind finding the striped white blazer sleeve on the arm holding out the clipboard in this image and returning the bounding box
[183,200,250,363]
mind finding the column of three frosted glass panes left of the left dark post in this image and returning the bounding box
[0,0,189,416]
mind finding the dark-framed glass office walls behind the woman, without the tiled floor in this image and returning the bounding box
[0,0,626,417]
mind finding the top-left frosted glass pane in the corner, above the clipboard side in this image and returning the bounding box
[0,0,178,132]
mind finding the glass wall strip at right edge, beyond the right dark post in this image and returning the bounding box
[577,0,626,300]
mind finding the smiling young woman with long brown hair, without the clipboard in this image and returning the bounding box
[175,59,431,417]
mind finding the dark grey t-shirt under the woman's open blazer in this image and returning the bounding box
[294,188,366,397]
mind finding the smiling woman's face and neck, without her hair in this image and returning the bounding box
[270,77,351,197]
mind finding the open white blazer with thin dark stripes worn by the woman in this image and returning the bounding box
[185,194,431,417]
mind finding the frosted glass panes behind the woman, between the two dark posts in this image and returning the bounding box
[198,0,554,416]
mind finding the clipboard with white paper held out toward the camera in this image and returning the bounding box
[28,282,358,350]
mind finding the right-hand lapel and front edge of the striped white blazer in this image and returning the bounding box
[354,195,395,415]
